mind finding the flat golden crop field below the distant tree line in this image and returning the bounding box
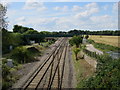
[89,35,120,47]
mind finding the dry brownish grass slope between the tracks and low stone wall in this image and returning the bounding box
[72,46,95,88]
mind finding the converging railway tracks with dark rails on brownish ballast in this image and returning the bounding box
[22,38,68,90]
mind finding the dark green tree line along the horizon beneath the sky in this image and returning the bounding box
[13,25,120,36]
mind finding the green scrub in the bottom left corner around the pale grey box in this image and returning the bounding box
[2,59,19,90]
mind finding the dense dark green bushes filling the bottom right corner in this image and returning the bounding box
[83,55,120,88]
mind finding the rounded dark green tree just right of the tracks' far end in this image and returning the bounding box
[69,36,83,48]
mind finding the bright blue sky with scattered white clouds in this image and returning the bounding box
[2,1,118,31]
